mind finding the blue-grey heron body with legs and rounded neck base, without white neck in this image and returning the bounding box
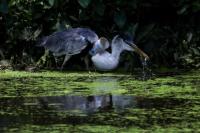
[39,28,109,70]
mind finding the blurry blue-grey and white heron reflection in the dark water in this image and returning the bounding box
[38,95,135,114]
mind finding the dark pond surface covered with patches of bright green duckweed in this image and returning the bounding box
[0,72,200,133]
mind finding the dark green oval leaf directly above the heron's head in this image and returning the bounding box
[114,11,126,28]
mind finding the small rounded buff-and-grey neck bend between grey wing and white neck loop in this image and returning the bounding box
[90,37,110,55]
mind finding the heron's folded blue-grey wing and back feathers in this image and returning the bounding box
[39,28,98,55]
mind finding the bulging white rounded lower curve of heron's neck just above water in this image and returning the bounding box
[92,52,119,71]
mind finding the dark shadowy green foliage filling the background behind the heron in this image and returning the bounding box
[0,0,200,67]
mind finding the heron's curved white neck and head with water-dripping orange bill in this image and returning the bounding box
[92,35,149,71]
